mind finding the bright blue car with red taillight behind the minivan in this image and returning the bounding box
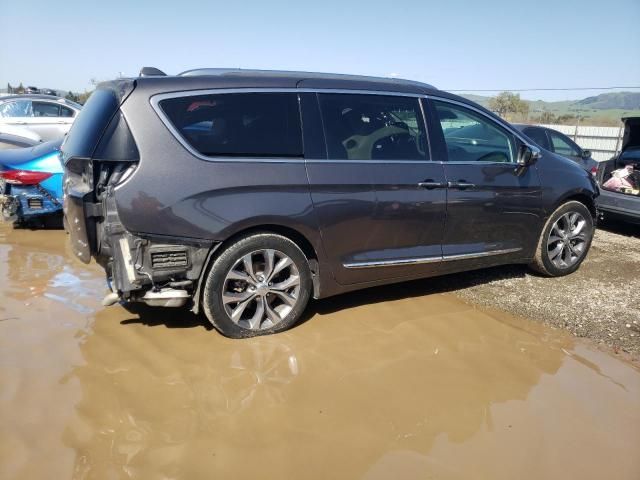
[0,139,63,223]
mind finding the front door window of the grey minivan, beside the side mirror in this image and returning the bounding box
[434,102,515,162]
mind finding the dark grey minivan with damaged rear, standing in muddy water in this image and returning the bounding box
[62,69,598,337]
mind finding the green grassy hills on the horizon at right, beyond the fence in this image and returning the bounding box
[462,92,640,125]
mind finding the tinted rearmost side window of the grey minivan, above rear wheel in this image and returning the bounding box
[160,93,302,157]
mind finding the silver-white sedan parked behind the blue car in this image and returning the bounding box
[0,95,82,142]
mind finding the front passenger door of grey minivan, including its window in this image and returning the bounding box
[430,99,543,263]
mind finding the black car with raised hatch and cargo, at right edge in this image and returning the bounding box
[596,117,640,224]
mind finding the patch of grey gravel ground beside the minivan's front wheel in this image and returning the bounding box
[447,223,640,361]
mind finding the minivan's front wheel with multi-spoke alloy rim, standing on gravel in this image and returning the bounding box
[530,200,594,277]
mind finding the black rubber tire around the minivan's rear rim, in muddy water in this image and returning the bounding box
[202,232,313,338]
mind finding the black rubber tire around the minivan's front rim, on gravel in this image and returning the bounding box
[529,200,594,277]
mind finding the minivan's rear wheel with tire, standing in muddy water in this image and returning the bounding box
[203,233,312,338]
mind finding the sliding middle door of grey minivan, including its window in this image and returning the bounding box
[304,93,446,284]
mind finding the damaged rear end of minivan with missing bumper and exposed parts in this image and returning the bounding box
[61,80,211,307]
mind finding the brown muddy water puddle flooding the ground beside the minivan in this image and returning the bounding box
[0,226,640,479]
